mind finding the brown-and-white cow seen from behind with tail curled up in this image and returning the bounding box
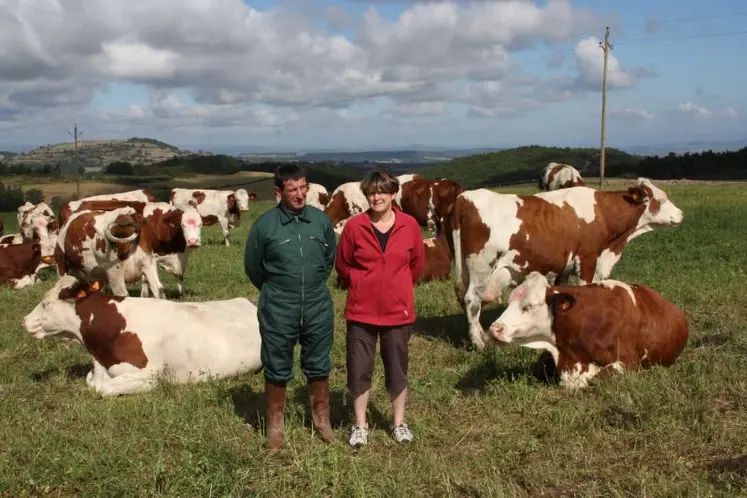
[55,207,163,297]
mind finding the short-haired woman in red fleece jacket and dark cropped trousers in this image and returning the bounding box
[335,171,425,447]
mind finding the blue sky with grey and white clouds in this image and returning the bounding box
[0,0,747,151]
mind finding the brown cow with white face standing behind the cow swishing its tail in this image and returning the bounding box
[62,201,202,297]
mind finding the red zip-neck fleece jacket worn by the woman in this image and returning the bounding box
[335,208,425,326]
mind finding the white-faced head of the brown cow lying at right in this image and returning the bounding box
[490,271,574,349]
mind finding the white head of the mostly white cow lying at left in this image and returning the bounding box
[22,275,101,342]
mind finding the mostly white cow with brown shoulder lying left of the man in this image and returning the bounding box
[23,275,262,396]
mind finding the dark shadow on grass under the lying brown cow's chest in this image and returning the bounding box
[456,346,557,394]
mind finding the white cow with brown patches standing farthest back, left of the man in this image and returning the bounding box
[169,188,241,247]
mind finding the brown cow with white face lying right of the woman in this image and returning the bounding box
[490,272,689,389]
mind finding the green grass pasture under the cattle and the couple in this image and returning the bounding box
[0,181,747,497]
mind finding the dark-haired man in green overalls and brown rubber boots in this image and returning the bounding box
[244,164,336,451]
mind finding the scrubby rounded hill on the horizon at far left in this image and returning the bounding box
[3,137,192,170]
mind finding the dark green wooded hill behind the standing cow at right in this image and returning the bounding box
[419,145,641,188]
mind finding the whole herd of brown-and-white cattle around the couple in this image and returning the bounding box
[0,163,688,396]
